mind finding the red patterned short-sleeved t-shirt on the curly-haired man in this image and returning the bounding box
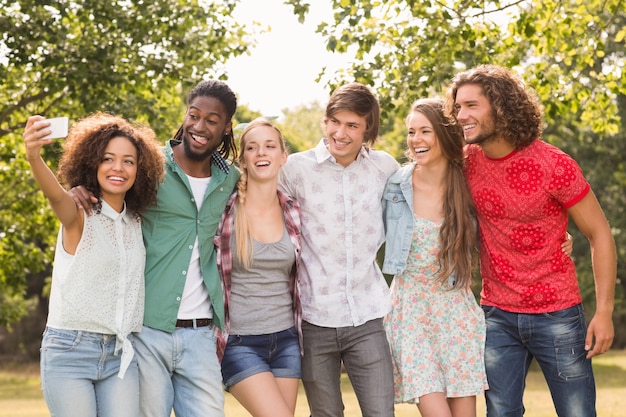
[466,140,590,313]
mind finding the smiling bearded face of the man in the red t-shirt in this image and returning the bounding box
[455,84,497,144]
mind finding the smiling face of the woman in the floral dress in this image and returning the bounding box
[406,111,447,166]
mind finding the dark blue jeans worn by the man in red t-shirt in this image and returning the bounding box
[483,304,596,417]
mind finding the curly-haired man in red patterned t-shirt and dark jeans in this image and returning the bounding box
[446,65,616,417]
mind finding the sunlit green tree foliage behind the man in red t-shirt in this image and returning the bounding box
[286,0,626,347]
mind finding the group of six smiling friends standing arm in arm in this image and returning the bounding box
[23,65,616,417]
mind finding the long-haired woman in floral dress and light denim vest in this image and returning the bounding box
[383,99,487,417]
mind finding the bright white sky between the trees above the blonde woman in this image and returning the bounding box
[219,0,348,116]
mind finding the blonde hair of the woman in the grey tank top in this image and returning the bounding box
[234,118,287,268]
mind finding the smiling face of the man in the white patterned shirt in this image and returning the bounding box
[325,111,367,167]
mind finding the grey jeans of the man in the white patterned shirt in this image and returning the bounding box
[302,318,394,417]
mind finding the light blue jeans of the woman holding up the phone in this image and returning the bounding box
[41,327,139,417]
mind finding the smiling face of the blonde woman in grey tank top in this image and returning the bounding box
[240,125,287,181]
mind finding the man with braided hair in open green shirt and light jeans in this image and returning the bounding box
[73,80,239,417]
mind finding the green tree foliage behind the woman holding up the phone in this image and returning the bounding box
[0,0,254,325]
